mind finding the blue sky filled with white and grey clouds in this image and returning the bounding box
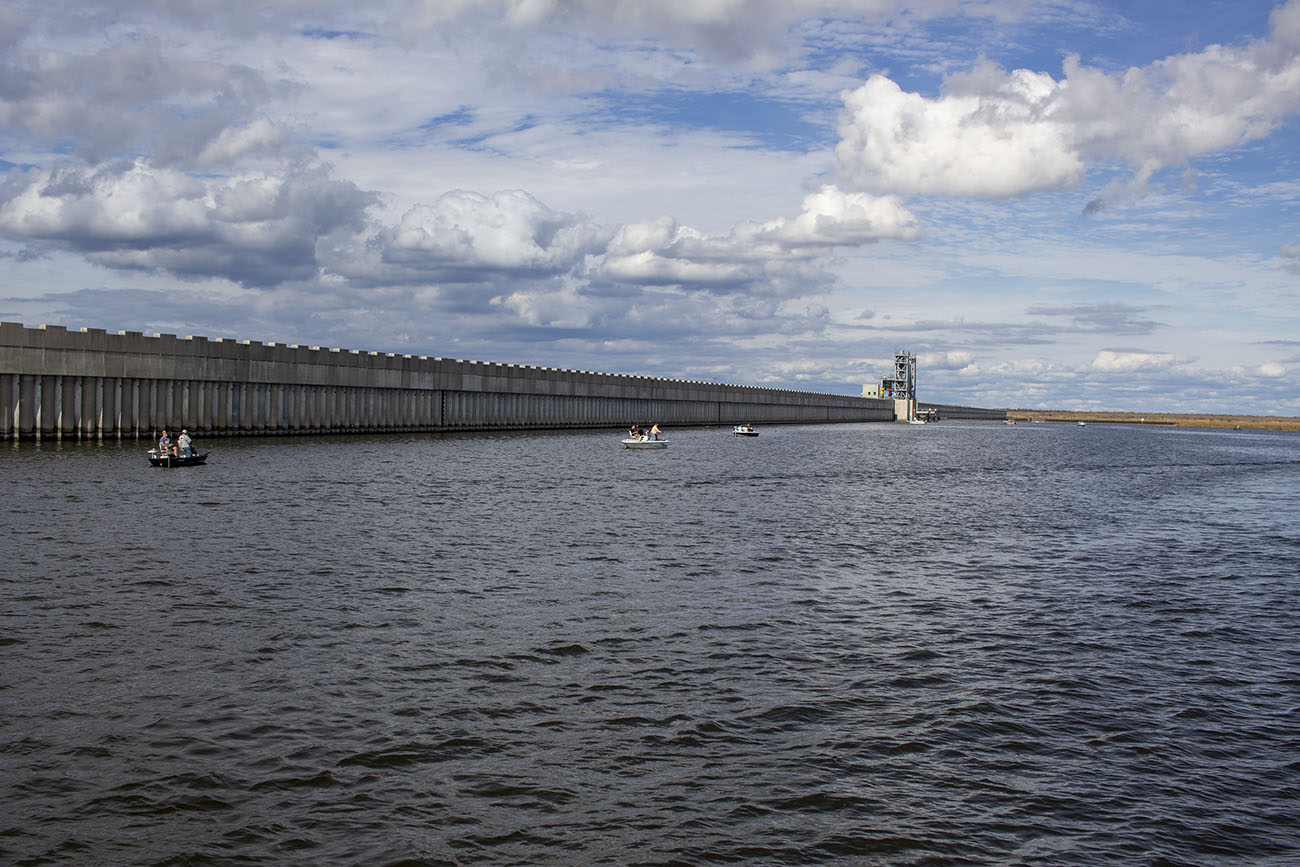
[0,0,1300,416]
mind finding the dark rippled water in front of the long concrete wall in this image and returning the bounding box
[0,422,1300,864]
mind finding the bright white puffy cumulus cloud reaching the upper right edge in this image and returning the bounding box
[836,0,1300,198]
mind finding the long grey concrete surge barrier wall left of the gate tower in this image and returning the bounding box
[0,322,893,439]
